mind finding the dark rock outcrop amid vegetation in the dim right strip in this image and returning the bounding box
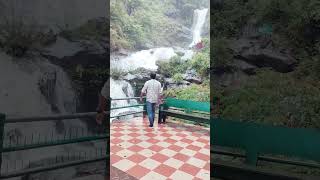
[212,36,298,88]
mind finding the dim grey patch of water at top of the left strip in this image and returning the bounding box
[0,0,109,32]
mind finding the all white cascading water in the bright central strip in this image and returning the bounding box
[110,9,208,121]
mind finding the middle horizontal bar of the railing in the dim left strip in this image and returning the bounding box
[2,135,109,152]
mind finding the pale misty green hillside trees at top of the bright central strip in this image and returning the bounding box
[110,0,209,50]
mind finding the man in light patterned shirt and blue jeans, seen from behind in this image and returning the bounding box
[140,73,161,127]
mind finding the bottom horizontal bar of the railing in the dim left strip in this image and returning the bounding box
[0,155,109,179]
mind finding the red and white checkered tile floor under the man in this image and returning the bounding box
[110,117,210,180]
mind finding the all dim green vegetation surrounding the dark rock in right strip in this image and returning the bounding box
[210,0,320,128]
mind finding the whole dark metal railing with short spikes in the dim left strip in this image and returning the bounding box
[0,112,110,179]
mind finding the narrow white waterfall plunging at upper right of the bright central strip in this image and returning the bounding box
[189,9,208,47]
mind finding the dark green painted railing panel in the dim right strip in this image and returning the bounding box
[210,118,320,167]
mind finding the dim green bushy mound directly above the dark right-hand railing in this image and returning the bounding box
[221,70,320,128]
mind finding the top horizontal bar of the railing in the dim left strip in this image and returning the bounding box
[5,112,102,124]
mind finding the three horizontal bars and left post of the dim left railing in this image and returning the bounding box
[0,112,110,179]
